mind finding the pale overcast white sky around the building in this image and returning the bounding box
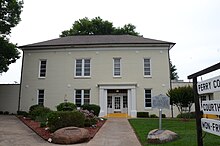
[0,0,220,84]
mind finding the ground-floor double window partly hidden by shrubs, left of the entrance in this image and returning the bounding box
[75,90,90,107]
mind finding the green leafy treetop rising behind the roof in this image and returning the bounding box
[60,17,139,37]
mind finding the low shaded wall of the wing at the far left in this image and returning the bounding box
[0,84,20,114]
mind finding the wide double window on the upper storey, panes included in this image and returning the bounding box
[75,59,91,77]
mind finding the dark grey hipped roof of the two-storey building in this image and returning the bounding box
[19,35,175,50]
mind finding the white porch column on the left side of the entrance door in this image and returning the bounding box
[99,88,107,117]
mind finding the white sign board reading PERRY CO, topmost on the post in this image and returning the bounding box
[197,76,220,94]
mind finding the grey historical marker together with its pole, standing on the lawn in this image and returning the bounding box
[152,94,170,130]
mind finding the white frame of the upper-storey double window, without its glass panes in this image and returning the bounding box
[74,58,91,78]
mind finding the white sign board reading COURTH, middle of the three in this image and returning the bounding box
[201,100,220,115]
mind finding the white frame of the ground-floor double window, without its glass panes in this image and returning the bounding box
[74,89,91,107]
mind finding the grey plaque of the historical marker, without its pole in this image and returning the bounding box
[152,94,170,109]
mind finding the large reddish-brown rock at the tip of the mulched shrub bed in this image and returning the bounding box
[52,127,90,144]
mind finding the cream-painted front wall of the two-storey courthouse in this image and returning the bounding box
[20,47,170,116]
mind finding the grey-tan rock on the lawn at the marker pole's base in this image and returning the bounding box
[147,129,178,144]
